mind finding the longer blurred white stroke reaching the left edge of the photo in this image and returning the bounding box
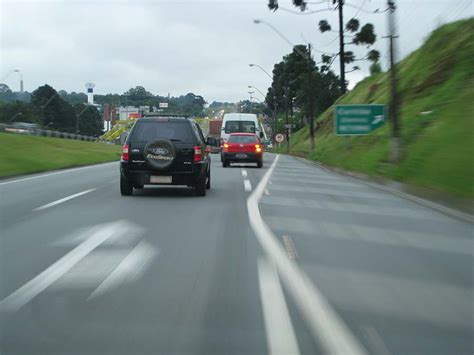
[0,221,130,313]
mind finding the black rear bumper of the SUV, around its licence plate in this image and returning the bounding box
[120,163,207,186]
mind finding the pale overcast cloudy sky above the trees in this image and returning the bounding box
[0,0,473,102]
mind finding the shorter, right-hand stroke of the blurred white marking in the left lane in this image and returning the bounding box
[87,240,157,300]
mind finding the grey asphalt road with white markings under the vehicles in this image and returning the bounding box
[0,154,474,355]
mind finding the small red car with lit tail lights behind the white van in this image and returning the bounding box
[221,133,263,168]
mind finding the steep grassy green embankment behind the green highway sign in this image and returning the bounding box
[282,18,474,198]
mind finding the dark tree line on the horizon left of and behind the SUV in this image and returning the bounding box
[0,84,206,136]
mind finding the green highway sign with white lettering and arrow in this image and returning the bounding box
[334,105,387,136]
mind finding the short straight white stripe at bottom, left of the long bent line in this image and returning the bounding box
[258,258,300,355]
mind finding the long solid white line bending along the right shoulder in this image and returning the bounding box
[247,156,367,355]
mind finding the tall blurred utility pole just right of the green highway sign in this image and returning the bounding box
[384,0,401,163]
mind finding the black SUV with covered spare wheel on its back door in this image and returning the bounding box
[120,116,211,196]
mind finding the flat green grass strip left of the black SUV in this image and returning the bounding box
[0,133,120,177]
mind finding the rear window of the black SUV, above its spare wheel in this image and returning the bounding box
[130,120,193,143]
